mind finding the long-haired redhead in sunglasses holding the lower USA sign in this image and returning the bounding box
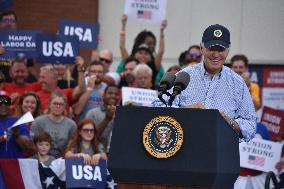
[65,118,107,165]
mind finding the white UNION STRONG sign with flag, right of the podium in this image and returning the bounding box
[239,138,282,172]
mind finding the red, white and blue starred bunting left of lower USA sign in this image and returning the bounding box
[0,159,65,189]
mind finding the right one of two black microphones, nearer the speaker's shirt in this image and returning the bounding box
[168,72,190,107]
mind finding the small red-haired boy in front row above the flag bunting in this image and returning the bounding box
[32,132,55,166]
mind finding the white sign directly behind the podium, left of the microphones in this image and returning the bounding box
[122,87,158,107]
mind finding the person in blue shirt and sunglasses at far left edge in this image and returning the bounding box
[0,95,34,159]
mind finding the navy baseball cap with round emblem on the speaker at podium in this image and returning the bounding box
[202,24,231,48]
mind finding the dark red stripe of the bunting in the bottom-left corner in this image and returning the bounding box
[0,159,25,189]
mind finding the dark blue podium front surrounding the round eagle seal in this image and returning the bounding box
[108,107,240,189]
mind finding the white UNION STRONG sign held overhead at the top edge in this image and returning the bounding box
[124,0,167,23]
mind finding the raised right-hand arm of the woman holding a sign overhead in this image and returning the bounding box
[155,20,168,70]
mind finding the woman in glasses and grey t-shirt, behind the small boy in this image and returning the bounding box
[32,92,76,158]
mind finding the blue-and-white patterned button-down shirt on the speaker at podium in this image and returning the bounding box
[153,63,256,141]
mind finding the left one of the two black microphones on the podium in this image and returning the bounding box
[158,72,176,106]
